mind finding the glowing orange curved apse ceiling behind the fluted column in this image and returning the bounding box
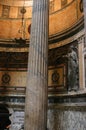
[0,0,83,39]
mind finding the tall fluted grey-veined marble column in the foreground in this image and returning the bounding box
[25,0,49,130]
